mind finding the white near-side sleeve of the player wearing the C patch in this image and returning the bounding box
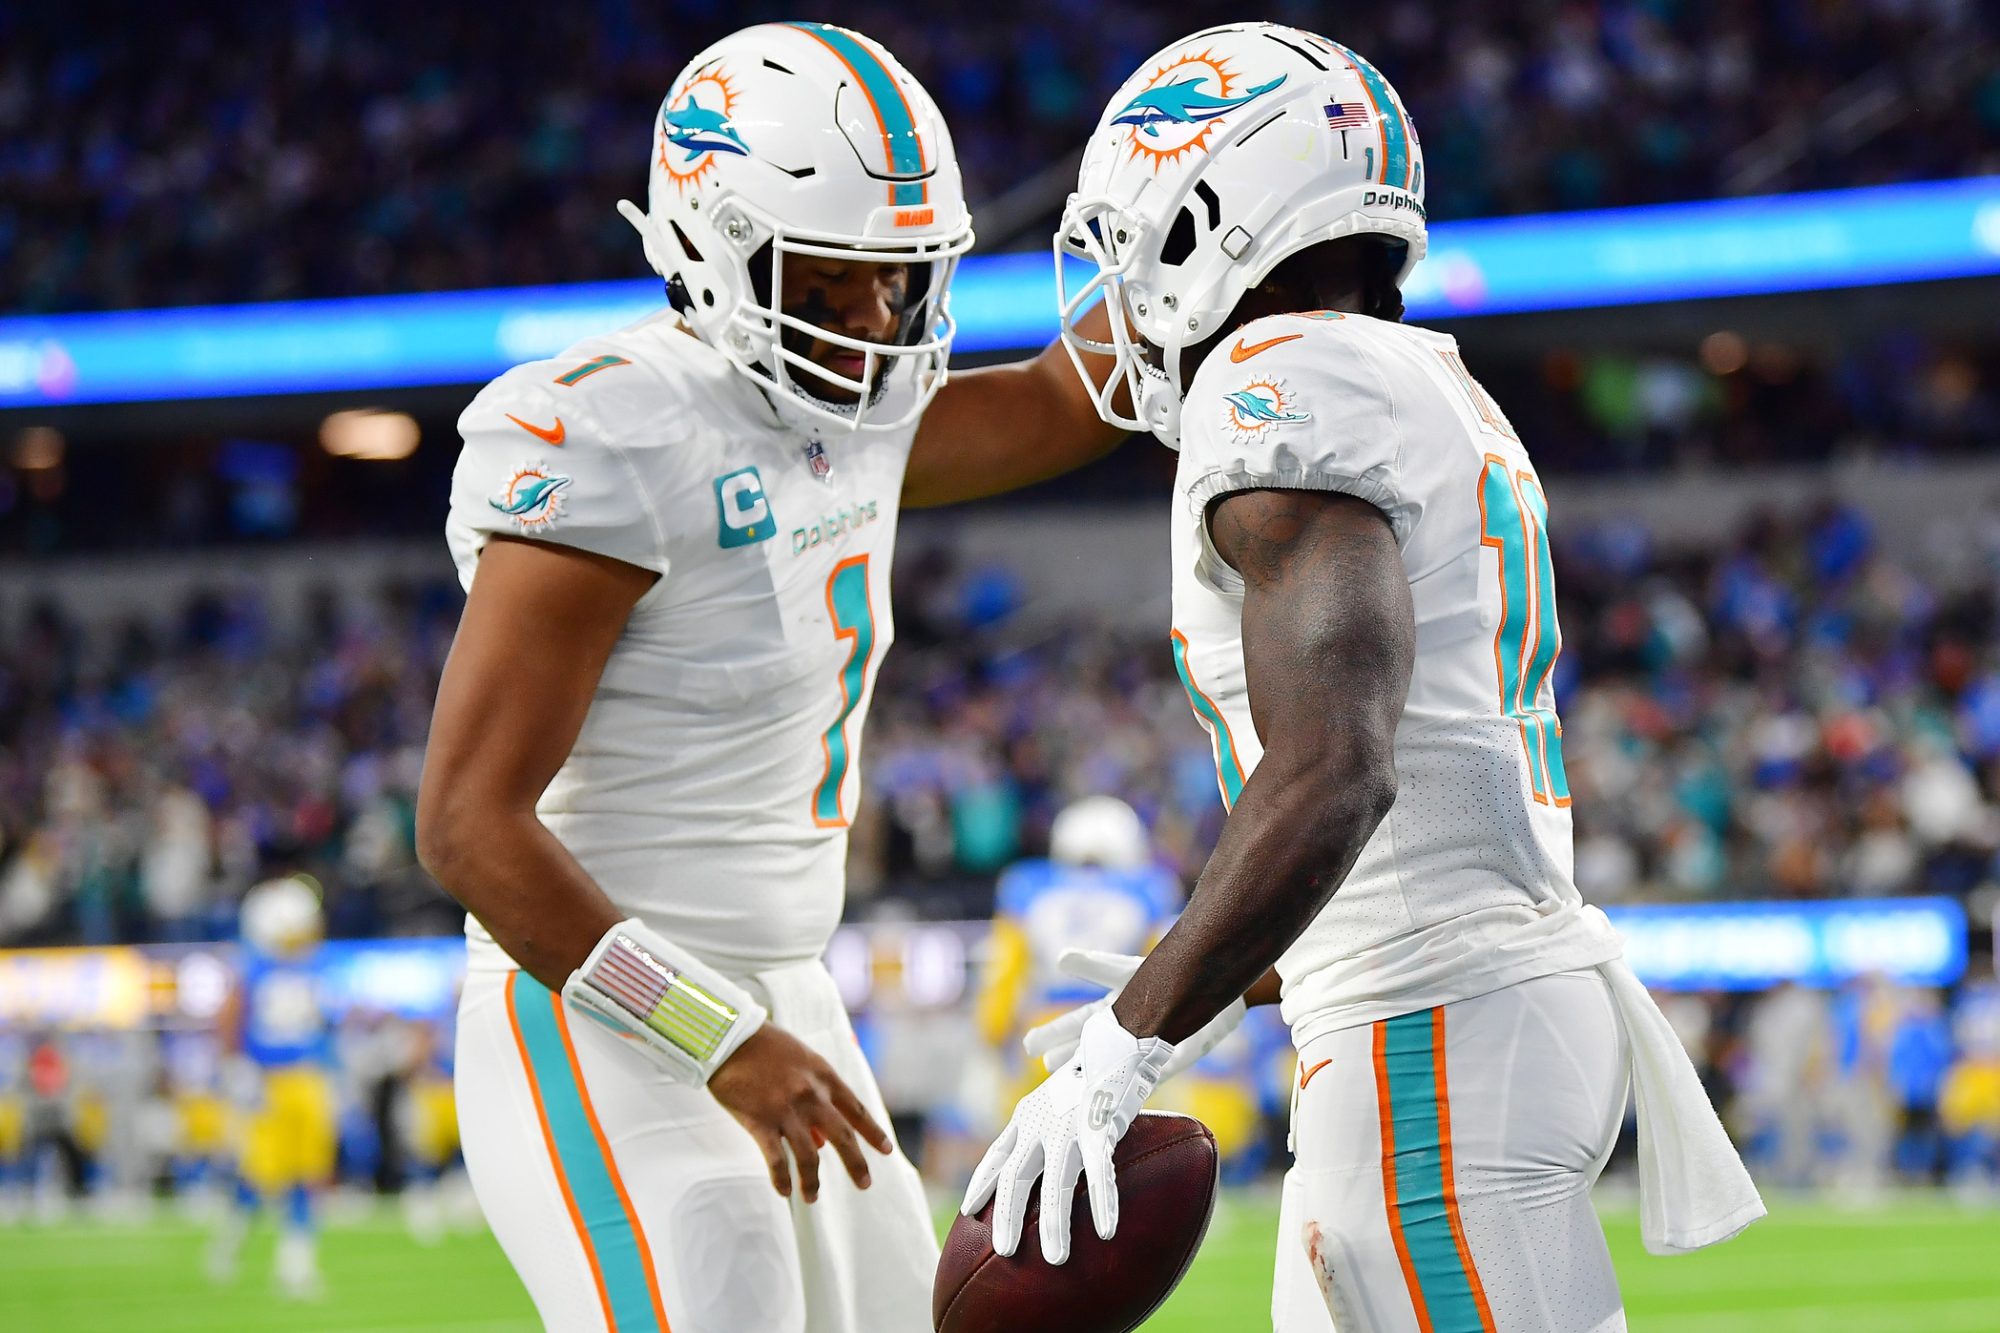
[448,360,668,586]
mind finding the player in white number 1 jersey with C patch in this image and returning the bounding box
[418,24,1122,1333]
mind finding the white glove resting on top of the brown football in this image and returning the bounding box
[960,1009,1174,1263]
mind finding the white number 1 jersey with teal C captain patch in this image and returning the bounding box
[446,312,916,975]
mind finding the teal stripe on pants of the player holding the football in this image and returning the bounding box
[1382,1009,1488,1333]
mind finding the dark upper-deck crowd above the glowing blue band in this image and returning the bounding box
[0,0,2000,312]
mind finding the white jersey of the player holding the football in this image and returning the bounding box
[1172,312,1620,1041]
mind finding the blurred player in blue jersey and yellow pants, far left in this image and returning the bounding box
[210,877,336,1299]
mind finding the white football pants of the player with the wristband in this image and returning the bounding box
[458,963,938,1333]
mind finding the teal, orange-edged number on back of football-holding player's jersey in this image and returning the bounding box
[1480,454,1570,805]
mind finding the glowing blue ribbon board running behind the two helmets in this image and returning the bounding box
[0,176,2000,408]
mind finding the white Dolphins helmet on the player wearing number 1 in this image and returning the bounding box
[618,22,972,430]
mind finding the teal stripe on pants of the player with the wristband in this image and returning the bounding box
[508,973,660,1333]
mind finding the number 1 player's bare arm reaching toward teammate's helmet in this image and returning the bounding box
[902,306,1126,508]
